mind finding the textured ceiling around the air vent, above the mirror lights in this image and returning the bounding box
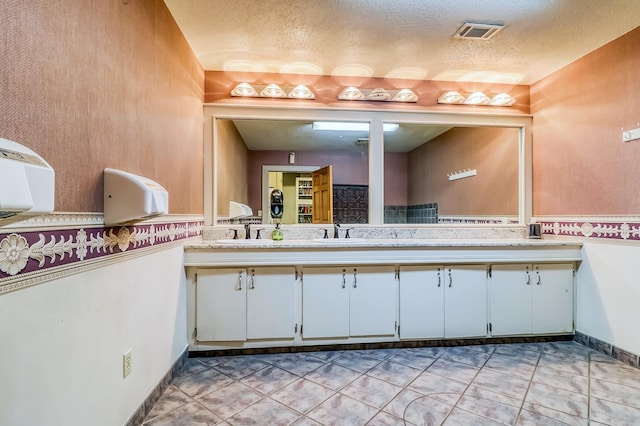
[165,0,640,85]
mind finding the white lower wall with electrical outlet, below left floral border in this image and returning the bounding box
[0,246,187,426]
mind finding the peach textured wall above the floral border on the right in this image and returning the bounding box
[531,27,640,215]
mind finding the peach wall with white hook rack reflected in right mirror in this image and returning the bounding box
[408,127,519,216]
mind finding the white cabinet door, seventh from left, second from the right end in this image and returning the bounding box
[489,264,534,336]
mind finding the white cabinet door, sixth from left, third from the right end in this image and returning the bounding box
[444,265,488,337]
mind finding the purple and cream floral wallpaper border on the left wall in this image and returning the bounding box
[0,217,204,293]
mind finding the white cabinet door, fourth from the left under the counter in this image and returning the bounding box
[347,266,398,336]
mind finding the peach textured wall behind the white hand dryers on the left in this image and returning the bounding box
[0,0,204,214]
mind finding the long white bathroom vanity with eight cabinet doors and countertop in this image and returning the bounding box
[185,230,581,351]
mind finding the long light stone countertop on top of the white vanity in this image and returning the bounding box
[184,238,582,250]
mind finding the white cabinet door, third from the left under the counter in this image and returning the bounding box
[302,267,349,339]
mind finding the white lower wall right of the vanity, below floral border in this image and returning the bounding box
[576,242,640,354]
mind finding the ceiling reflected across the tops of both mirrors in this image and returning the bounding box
[233,120,451,152]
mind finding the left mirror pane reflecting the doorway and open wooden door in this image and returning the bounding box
[215,119,369,224]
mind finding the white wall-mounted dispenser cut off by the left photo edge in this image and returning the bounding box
[0,138,55,222]
